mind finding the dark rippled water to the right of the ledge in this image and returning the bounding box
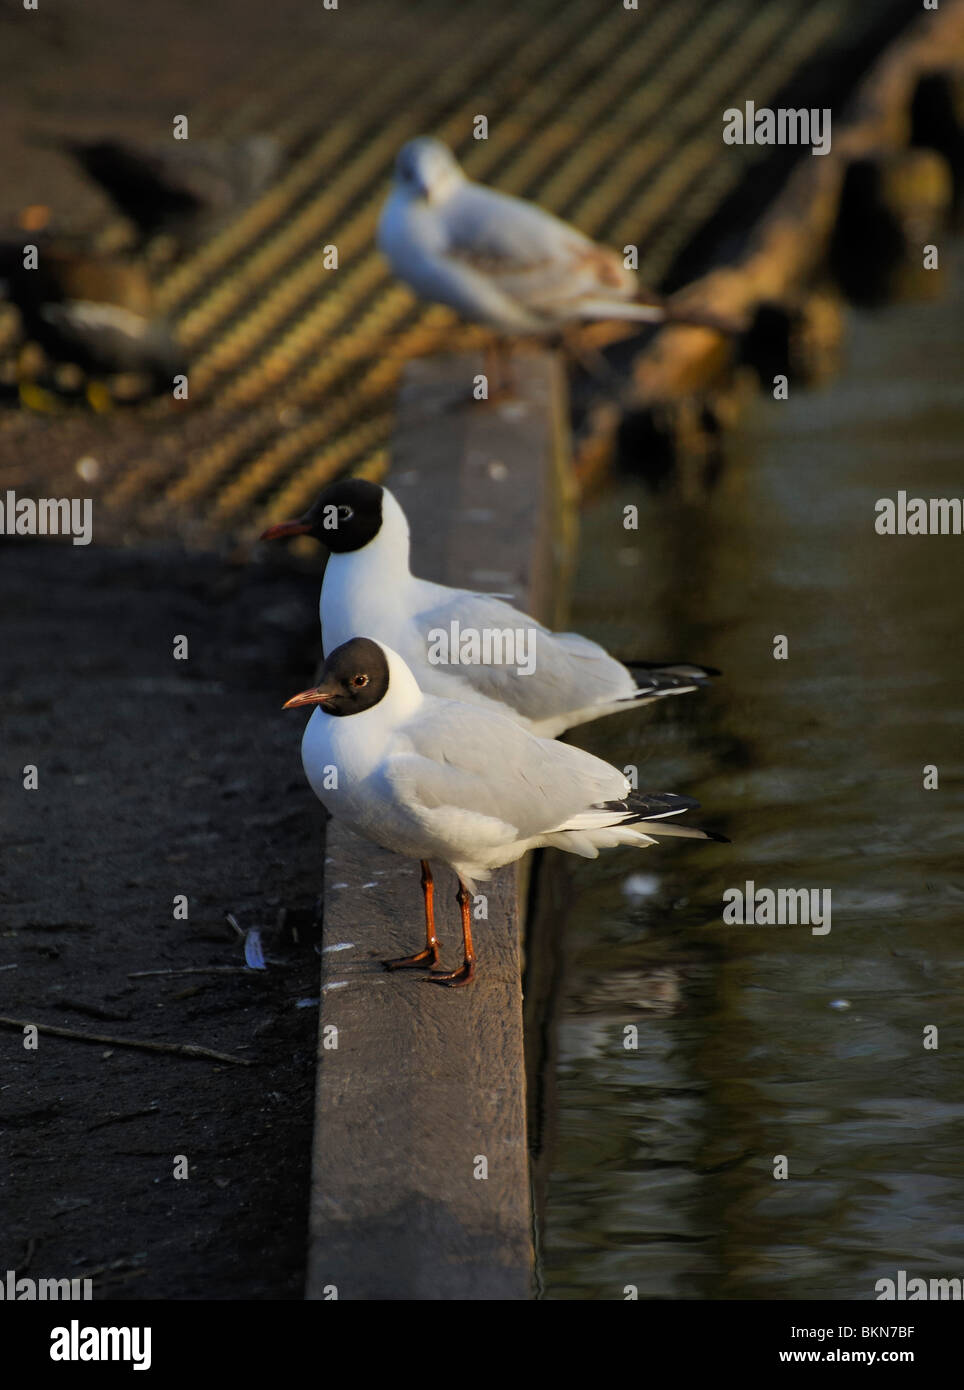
[543,247,964,1300]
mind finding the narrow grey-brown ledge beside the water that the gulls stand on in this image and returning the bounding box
[307,353,568,1300]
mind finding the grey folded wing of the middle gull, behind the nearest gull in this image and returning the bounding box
[415,589,636,724]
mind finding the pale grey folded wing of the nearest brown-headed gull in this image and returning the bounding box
[386,699,629,840]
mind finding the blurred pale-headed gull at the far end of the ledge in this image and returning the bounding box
[378,136,739,336]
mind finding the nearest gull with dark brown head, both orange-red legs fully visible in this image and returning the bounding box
[285,637,724,986]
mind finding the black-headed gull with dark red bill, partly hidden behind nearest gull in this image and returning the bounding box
[263,478,718,738]
